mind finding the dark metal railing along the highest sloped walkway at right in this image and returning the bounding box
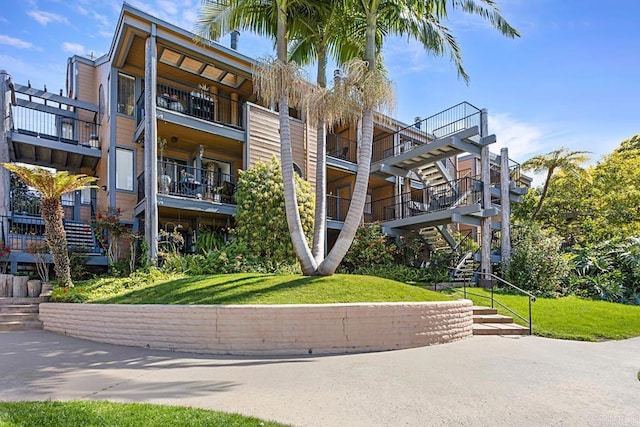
[371,102,481,162]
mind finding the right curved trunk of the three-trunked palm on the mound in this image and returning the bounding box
[318,5,377,276]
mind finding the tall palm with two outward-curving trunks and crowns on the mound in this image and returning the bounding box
[198,0,518,275]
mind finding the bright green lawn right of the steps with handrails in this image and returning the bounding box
[455,288,640,341]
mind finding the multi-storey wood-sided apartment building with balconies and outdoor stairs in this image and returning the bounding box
[0,4,523,278]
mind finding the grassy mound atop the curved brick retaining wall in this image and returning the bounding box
[81,273,451,305]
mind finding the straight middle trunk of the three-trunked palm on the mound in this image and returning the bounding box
[312,47,327,264]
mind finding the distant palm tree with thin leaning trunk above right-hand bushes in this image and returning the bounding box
[522,147,589,220]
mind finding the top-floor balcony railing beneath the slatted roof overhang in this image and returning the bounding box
[136,82,244,129]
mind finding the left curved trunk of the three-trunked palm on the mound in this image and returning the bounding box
[276,0,317,275]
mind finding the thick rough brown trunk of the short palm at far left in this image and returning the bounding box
[42,198,73,287]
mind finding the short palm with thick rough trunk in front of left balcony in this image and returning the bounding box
[2,163,95,287]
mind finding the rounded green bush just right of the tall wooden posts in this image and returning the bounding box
[503,223,569,296]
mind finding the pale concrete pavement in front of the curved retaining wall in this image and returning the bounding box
[0,332,640,426]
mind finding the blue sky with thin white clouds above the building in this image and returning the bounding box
[0,0,640,167]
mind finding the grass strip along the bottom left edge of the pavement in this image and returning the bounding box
[0,401,284,427]
